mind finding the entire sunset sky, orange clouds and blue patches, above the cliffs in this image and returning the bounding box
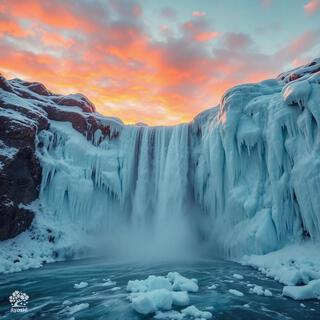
[0,0,320,125]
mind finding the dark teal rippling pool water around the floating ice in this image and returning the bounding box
[0,260,320,320]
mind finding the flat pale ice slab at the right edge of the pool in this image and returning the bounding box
[282,279,320,300]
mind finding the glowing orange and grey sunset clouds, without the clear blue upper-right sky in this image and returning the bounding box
[0,0,320,124]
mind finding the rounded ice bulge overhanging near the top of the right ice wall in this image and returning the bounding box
[283,80,311,106]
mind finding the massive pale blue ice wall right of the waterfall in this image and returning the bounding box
[195,74,320,255]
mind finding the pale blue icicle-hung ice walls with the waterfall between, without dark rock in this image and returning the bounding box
[34,57,320,257]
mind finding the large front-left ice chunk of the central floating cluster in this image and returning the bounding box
[130,289,173,314]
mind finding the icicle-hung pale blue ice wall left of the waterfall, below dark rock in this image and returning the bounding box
[38,121,121,231]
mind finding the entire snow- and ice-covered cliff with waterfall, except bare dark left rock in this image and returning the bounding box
[0,59,320,270]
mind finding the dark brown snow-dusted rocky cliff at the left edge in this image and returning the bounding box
[0,75,117,240]
